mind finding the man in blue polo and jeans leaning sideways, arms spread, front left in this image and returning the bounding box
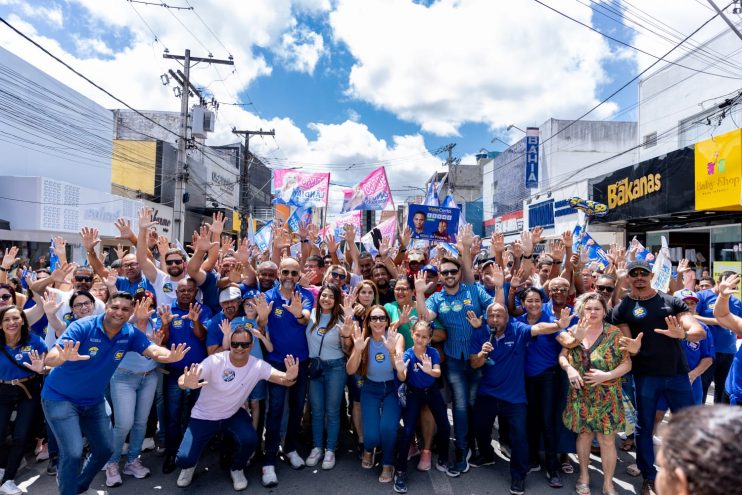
[41,292,188,495]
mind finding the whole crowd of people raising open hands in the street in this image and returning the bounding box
[0,208,742,495]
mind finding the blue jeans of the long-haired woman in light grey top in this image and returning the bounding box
[309,358,348,452]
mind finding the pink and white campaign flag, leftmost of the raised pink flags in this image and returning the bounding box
[273,169,330,207]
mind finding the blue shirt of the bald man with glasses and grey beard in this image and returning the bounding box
[265,285,314,362]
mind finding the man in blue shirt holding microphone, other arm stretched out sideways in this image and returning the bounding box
[469,302,570,495]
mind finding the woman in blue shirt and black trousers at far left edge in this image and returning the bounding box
[0,305,47,495]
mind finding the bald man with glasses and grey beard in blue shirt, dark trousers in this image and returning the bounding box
[258,257,314,487]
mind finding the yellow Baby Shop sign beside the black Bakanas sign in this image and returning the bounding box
[695,129,742,211]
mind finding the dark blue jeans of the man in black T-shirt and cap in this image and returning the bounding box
[634,373,693,480]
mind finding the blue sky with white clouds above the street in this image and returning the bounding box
[0,0,724,211]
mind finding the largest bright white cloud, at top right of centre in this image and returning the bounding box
[330,0,615,135]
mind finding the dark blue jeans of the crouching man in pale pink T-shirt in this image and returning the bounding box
[175,408,258,471]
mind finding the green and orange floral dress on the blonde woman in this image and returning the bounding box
[562,324,629,435]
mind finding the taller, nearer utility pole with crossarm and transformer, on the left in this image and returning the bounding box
[162,49,234,242]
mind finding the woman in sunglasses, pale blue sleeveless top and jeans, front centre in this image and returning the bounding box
[346,304,404,483]
